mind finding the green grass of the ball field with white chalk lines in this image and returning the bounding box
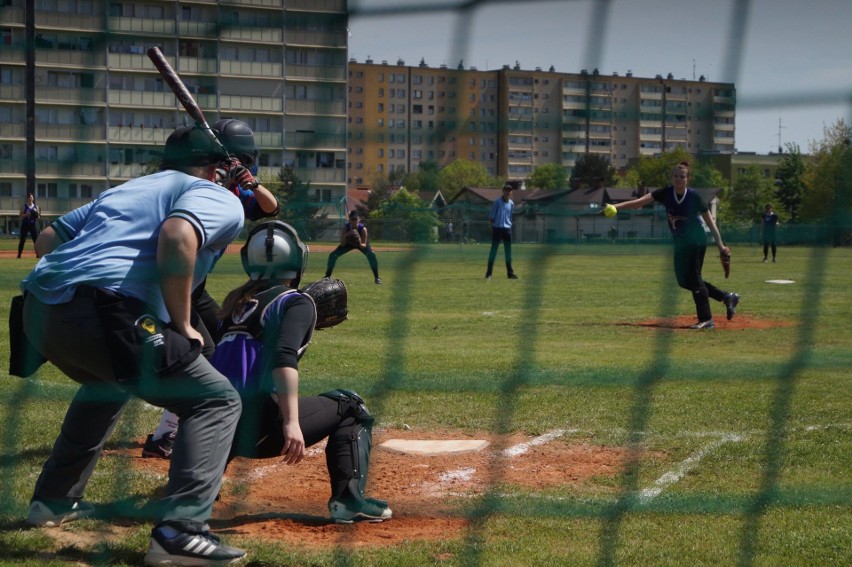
[0,241,852,566]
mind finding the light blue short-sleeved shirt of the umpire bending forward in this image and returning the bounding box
[21,170,244,322]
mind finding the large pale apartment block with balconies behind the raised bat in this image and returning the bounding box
[0,0,348,233]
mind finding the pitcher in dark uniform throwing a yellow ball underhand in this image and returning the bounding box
[608,162,740,329]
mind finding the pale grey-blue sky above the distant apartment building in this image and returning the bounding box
[349,0,852,154]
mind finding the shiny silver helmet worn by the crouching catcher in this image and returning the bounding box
[240,221,308,287]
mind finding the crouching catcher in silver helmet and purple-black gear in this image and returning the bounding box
[211,221,392,523]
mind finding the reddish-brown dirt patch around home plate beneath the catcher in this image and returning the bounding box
[121,430,640,547]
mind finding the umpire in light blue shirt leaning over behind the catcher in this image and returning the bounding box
[21,128,245,565]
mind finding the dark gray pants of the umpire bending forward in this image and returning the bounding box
[24,293,242,532]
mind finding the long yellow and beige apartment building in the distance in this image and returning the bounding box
[347,60,736,189]
